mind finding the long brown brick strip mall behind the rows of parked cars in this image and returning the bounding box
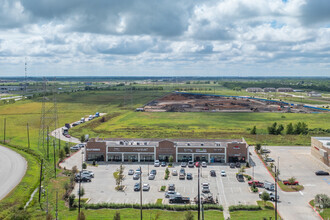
[85,138,249,163]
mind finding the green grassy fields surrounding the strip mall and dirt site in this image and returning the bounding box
[0,85,330,219]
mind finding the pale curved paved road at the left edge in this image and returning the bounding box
[0,146,27,200]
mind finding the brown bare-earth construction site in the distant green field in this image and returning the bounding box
[142,92,328,113]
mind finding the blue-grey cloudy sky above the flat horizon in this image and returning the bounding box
[0,0,330,77]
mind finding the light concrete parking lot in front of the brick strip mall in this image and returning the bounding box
[75,163,258,206]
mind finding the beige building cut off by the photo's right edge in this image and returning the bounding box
[311,137,330,166]
